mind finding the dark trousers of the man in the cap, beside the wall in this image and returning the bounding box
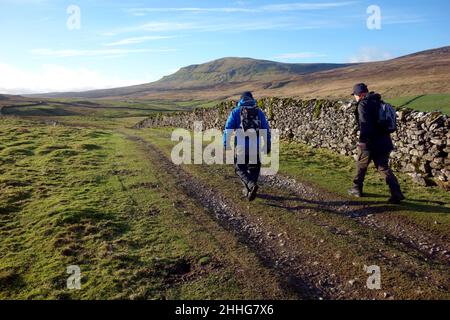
[353,149,401,196]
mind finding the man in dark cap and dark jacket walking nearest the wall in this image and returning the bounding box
[348,83,405,203]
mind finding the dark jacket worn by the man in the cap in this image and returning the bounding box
[355,92,394,154]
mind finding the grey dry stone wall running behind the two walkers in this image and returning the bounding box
[137,98,450,190]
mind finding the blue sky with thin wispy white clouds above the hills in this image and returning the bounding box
[0,0,450,93]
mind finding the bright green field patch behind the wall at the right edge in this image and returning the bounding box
[387,94,450,115]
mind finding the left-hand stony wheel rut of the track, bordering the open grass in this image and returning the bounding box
[128,136,352,299]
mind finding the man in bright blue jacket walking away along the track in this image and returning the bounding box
[224,92,271,201]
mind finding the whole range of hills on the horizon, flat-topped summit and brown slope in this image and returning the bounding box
[27,47,450,100]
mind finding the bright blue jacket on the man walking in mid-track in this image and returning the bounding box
[223,100,271,153]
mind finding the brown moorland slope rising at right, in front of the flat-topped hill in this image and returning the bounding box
[278,47,450,97]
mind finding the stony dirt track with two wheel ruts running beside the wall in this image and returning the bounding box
[128,136,449,299]
